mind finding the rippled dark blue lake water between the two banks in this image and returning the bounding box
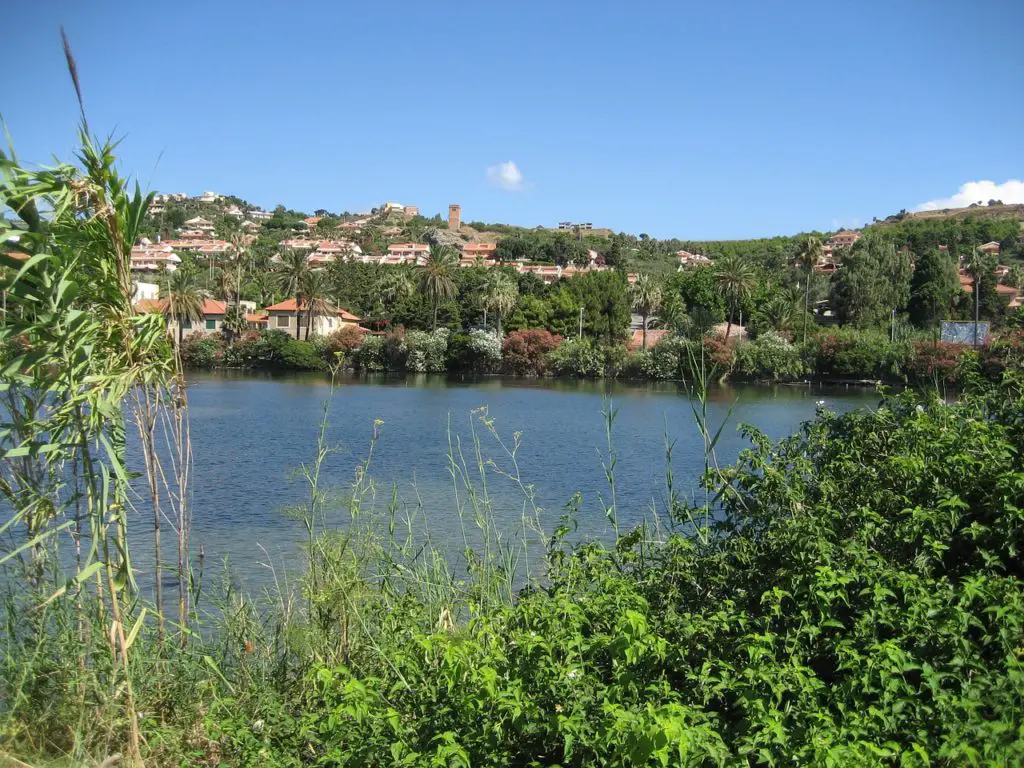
[128,372,879,586]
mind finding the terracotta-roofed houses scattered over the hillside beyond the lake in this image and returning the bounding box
[131,190,1022,343]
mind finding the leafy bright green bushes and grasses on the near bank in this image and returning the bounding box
[3,382,1024,766]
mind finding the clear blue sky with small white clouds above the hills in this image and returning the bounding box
[0,0,1024,239]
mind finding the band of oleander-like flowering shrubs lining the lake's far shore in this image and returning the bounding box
[180,329,1024,388]
